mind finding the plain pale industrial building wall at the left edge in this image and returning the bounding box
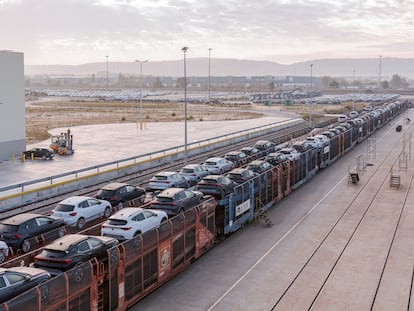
[0,51,26,161]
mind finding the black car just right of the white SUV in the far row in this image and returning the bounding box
[94,182,146,210]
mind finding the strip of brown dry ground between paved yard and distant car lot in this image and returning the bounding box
[26,98,360,144]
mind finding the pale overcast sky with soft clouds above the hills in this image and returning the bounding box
[0,0,414,65]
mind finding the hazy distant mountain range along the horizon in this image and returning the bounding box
[25,57,414,80]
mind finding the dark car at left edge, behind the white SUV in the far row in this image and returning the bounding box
[0,213,65,253]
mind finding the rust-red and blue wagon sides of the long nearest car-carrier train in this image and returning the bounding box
[0,101,409,311]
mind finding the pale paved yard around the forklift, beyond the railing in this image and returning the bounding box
[0,107,297,187]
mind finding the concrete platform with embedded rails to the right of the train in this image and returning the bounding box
[131,109,414,311]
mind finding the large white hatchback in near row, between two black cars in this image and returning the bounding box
[101,207,168,241]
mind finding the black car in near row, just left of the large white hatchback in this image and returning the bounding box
[33,234,119,275]
